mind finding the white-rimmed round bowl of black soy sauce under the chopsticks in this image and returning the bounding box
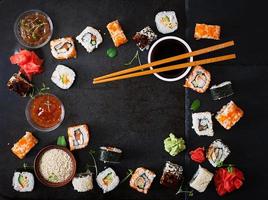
[148,36,193,82]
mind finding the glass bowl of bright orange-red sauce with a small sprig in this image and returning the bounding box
[25,93,65,132]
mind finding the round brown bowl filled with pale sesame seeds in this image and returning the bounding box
[34,145,76,187]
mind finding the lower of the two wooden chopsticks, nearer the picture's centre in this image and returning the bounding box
[93,54,236,84]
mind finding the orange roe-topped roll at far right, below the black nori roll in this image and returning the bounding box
[216,101,244,130]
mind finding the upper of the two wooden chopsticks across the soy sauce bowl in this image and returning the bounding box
[93,41,234,81]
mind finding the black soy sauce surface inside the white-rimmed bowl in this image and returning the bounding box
[151,39,189,78]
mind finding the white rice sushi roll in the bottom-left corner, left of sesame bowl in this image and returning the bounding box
[12,171,34,192]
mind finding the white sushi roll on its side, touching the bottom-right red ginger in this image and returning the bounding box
[190,165,213,192]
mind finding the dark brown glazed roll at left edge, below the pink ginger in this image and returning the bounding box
[7,73,33,97]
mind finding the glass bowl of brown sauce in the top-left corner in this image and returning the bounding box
[14,10,53,49]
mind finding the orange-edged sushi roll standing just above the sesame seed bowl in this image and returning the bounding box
[67,124,90,151]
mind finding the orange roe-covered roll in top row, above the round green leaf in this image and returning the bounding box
[106,20,128,47]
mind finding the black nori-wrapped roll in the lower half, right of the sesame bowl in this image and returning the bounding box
[99,147,122,163]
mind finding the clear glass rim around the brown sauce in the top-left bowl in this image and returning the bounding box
[14,9,53,49]
